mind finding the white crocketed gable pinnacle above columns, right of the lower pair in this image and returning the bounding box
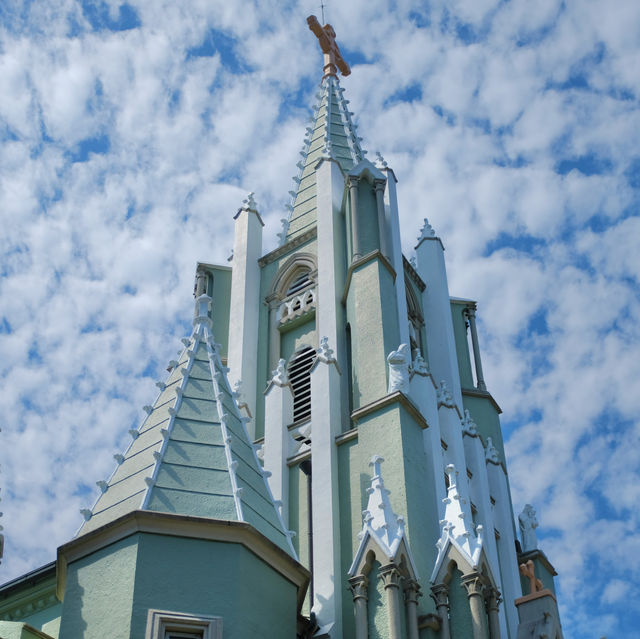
[431,464,484,583]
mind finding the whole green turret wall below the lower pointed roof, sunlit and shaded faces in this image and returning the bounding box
[60,533,297,639]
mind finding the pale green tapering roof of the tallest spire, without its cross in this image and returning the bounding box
[282,75,366,242]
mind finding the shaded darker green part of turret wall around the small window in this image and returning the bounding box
[132,534,296,639]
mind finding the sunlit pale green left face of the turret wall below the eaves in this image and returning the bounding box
[60,536,138,639]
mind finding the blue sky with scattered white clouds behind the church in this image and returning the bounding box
[0,0,640,639]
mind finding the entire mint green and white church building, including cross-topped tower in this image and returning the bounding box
[0,19,562,639]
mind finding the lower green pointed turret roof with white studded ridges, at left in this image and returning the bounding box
[78,295,295,557]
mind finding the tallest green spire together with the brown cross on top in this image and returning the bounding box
[280,16,366,244]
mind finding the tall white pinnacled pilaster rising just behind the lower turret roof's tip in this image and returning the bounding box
[228,194,264,438]
